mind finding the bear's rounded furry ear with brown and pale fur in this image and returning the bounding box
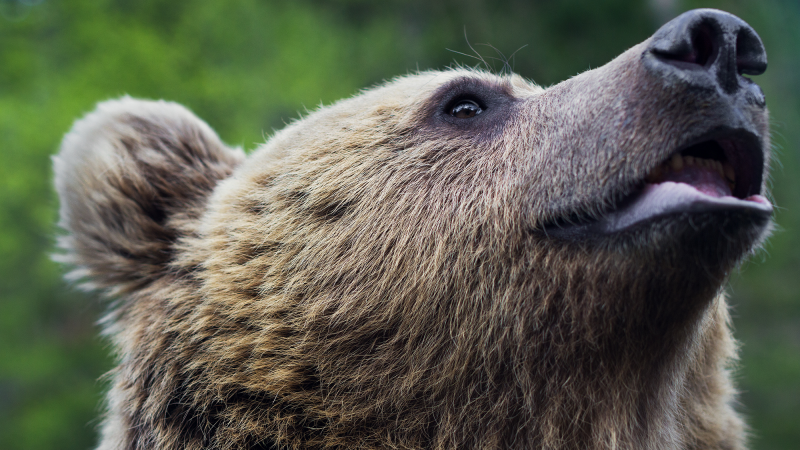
[53,97,244,295]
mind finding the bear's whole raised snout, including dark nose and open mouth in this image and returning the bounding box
[531,9,772,250]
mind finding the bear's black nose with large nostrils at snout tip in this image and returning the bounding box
[647,9,767,94]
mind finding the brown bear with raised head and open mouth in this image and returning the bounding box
[55,10,772,450]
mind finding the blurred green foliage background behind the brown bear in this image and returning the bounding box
[0,0,800,450]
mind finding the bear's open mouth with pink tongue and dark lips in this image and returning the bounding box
[546,130,772,236]
